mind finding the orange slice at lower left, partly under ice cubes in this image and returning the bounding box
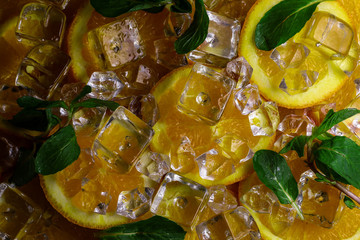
[40,136,153,229]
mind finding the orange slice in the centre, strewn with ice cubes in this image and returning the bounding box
[150,66,275,186]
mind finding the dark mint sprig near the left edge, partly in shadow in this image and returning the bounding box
[9,86,119,186]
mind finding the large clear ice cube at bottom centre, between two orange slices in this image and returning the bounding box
[151,172,207,227]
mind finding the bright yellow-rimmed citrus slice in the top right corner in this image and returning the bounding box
[239,0,356,108]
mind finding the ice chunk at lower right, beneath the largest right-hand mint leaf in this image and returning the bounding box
[296,170,344,228]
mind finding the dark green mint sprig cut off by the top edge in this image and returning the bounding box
[90,0,209,54]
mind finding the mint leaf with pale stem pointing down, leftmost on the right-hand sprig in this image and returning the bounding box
[253,150,304,219]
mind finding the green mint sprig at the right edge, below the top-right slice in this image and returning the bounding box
[253,108,360,209]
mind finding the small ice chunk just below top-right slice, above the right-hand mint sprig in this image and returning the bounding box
[277,114,315,136]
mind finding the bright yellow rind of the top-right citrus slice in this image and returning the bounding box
[239,0,354,108]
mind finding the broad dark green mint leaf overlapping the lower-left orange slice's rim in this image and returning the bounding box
[35,125,80,175]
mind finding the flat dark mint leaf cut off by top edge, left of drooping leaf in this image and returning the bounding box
[90,0,172,17]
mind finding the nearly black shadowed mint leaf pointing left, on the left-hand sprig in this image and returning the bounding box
[9,108,49,132]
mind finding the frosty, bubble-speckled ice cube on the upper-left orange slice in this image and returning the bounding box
[89,17,145,69]
